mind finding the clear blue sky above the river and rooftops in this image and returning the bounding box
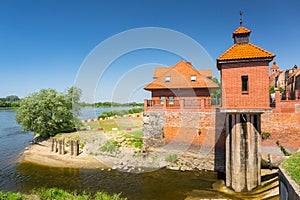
[0,0,300,102]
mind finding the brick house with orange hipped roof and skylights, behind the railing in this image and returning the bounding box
[144,61,219,111]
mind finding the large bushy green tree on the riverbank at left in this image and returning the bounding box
[16,89,80,137]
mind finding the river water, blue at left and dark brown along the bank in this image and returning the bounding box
[0,109,225,200]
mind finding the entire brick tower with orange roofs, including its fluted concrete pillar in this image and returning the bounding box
[217,23,275,192]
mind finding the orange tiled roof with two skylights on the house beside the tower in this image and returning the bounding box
[144,61,219,90]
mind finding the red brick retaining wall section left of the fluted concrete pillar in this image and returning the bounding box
[164,112,225,147]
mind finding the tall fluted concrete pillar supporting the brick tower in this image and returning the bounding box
[226,114,261,192]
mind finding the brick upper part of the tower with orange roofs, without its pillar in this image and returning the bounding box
[217,26,275,109]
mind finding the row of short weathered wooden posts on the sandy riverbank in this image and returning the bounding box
[51,139,79,156]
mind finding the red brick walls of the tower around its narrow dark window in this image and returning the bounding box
[221,61,270,109]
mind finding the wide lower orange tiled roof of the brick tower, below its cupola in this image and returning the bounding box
[217,43,275,64]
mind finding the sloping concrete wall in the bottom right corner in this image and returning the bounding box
[278,168,300,200]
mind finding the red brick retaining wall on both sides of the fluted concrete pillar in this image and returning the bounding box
[164,112,300,150]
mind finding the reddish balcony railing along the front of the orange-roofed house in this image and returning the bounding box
[144,97,214,112]
